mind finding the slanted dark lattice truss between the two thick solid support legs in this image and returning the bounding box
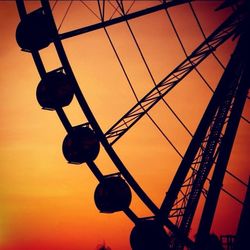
[163,38,246,239]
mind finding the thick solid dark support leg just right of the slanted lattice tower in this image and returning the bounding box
[197,31,250,249]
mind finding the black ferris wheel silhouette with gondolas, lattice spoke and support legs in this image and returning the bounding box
[16,0,250,250]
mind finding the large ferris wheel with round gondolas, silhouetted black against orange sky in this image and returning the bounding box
[16,0,250,250]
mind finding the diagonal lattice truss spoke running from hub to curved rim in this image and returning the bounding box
[105,6,244,145]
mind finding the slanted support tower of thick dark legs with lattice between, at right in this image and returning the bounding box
[161,3,250,250]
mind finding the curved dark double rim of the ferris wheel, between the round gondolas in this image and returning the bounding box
[16,0,195,245]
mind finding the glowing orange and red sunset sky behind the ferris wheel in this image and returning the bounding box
[0,0,250,250]
